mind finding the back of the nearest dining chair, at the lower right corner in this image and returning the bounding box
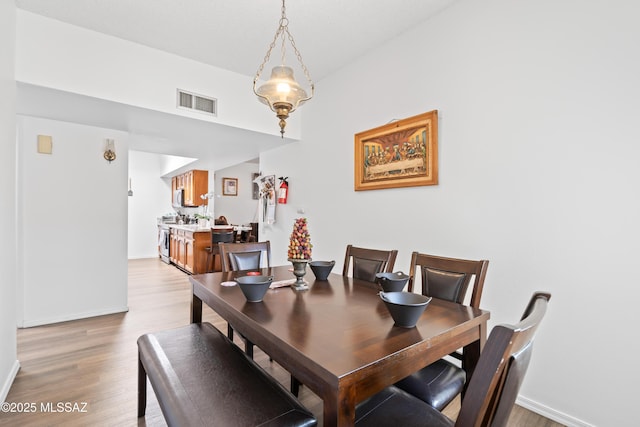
[455,292,551,427]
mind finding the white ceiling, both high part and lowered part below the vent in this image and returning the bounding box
[15,0,456,169]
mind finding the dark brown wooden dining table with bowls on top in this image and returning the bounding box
[189,265,490,426]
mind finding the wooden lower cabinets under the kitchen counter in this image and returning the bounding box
[169,226,211,274]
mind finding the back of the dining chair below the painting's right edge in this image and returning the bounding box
[409,252,489,308]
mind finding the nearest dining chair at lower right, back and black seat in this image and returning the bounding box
[355,292,551,427]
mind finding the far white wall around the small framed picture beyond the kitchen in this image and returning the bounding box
[215,163,260,224]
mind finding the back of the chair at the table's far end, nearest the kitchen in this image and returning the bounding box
[219,240,271,272]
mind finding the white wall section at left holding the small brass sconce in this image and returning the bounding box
[17,116,128,326]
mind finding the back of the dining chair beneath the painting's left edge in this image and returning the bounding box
[342,245,398,282]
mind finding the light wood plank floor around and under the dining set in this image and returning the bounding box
[0,259,560,427]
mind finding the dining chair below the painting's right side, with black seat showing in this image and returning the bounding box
[395,252,489,411]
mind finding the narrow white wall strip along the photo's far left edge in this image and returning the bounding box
[0,0,20,402]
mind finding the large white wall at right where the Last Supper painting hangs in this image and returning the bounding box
[260,0,640,426]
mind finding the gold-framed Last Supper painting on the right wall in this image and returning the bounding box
[354,110,438,191]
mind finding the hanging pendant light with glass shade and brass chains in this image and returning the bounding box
[253,0,314,138]
